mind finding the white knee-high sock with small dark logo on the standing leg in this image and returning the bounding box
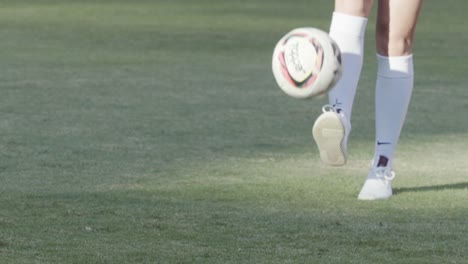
[374,55,413,167]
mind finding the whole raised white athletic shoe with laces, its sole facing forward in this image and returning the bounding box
[312,105,351,166]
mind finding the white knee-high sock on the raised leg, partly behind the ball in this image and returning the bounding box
[328,12,367,119]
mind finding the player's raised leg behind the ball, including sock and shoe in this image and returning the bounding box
[312,0,373,166]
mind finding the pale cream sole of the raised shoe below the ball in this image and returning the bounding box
[312,112,346,166]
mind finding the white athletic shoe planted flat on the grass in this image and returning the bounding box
[358,167,395,200]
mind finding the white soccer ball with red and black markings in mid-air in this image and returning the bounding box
[272,28,341,98]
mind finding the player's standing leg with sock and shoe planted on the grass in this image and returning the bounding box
[359,0,422,200]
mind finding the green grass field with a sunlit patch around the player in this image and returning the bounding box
[0,0,468,264]
